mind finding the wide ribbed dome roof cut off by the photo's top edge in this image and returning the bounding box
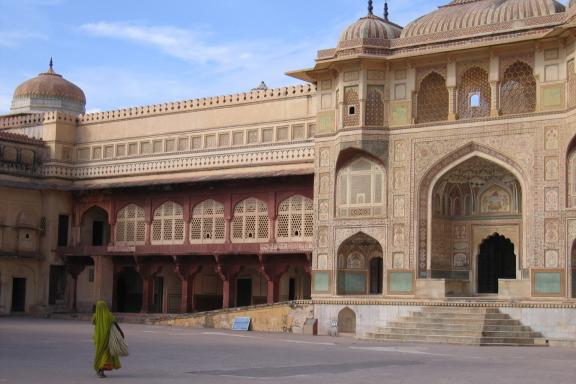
[402,0,574,37]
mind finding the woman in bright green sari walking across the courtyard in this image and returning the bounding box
[92,301,122,378]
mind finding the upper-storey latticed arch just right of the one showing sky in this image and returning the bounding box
[500,61,536,115]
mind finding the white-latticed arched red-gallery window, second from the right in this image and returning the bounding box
[232,198,268,243]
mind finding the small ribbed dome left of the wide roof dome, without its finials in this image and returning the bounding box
[338,14,402,47]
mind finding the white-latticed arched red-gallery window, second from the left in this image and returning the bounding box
[151,201,184,244]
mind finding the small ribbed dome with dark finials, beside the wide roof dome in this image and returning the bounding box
[338,1,402,49]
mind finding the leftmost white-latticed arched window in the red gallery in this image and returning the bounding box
[114,204,146,246]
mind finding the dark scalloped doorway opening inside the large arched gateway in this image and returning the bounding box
[478,233,516,293]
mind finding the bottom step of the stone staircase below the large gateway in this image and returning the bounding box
[368,333,534,346]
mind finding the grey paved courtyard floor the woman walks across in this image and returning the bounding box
[0,318,576,384]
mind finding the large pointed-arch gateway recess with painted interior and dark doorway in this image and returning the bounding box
[429,156,522,296]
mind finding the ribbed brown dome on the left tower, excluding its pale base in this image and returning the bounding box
[14,66,86,104]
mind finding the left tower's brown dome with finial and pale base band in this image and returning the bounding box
[10,59,86,115]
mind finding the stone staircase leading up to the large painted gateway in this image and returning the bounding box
[365,307,546,346]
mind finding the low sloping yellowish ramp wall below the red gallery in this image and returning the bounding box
[147,301,313,333]
